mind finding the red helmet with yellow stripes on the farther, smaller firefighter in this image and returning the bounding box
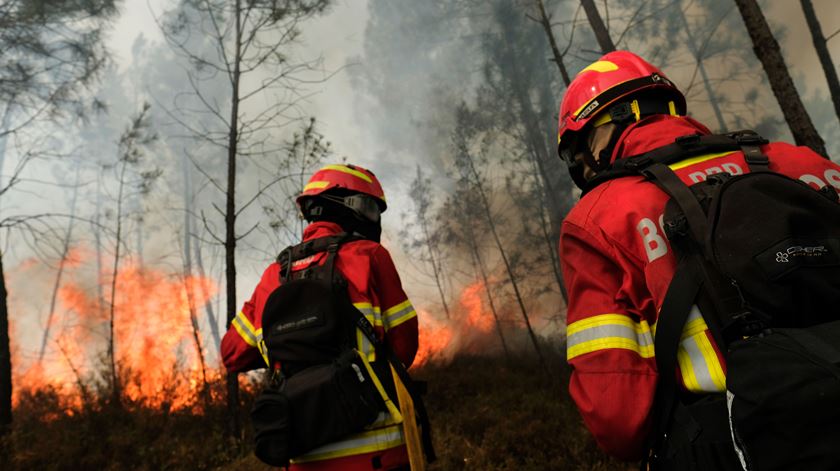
[295,164,388,221]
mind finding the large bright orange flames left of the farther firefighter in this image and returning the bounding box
[13,249,216,409]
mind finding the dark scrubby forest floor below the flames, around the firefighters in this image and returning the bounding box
[0,353,637,471]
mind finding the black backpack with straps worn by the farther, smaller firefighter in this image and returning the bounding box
[251,233,434,466]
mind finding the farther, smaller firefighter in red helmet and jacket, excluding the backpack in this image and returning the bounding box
[221,165,418,471]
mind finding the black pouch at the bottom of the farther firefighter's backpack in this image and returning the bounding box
[251,350,385,466]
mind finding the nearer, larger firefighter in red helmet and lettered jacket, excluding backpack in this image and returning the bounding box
[558,51,840,460]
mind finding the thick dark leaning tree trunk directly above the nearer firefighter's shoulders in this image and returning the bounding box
[735,0,828,157]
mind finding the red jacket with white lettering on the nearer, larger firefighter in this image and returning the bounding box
[560,115,840,460]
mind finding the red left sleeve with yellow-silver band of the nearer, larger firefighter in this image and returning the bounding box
[560,222,656,460]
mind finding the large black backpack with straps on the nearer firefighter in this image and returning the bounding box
[595,131,840,471]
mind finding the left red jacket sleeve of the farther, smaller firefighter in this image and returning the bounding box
[221,266,277,373]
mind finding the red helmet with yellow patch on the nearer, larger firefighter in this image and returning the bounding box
[557,51,685,153]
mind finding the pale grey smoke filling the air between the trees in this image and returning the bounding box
[6,0,840,398]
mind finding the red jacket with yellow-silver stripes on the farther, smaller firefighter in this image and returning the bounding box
[221,222,418,471]
